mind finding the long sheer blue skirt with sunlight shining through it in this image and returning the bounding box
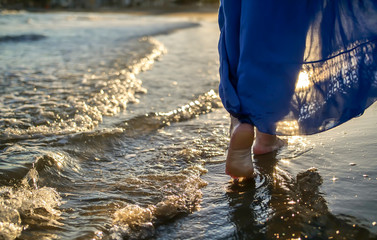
[219,0,377,135]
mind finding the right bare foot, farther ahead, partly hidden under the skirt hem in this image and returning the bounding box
[253,130,286,155]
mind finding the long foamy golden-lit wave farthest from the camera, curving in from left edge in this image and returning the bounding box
[0,38,166,140]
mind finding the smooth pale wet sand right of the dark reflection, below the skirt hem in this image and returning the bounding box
[306,104,377,233]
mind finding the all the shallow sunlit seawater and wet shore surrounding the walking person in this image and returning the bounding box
[0,12,377,239]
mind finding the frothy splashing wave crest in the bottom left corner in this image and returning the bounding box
[0,170,63,239]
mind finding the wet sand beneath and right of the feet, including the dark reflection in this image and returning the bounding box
[157,104,377,239]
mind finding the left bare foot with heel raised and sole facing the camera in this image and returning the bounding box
[225,123,254,178]
